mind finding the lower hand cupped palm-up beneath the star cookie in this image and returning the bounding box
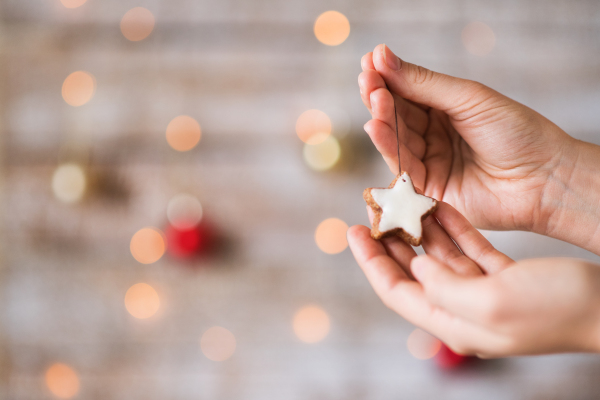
[348,202,600,358]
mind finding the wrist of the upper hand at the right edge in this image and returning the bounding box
[539,134,600,254]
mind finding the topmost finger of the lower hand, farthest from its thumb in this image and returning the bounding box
[434,202,514,274]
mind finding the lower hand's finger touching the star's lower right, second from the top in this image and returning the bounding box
[422,214,483,276]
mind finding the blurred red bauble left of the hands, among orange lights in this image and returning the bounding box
[165,221,216,259]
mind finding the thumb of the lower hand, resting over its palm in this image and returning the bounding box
[410,255,492,320]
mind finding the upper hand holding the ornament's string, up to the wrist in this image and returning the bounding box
[359,45,580,241]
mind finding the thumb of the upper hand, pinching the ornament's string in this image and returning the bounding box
[373,44,503,120]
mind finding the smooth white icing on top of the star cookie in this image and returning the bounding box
[371,172,436,239]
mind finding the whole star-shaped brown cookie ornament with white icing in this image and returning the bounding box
[363,172,438,246]
